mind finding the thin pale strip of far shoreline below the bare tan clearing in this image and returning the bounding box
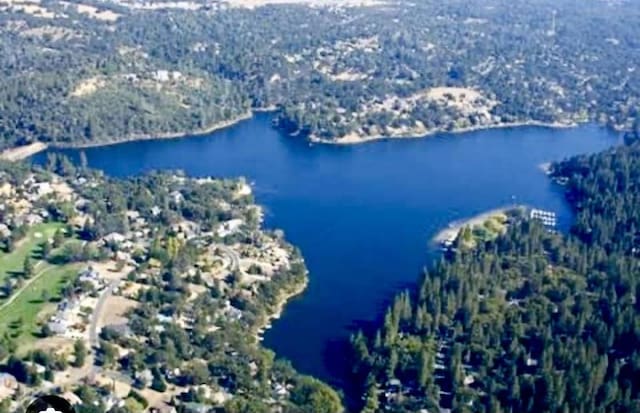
[309,121,580,145]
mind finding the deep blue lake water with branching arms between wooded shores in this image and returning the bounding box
[34,113,618,385]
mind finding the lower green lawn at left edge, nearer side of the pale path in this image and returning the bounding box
[0,264,79,349]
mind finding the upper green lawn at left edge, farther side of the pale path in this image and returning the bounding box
[0,222,62,286]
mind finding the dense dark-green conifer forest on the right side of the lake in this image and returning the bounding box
[353,134,640,413]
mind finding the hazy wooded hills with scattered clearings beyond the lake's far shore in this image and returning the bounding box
[0,0,640,147]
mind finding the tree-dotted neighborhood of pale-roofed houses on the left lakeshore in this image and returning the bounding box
[0,161,319,412]
